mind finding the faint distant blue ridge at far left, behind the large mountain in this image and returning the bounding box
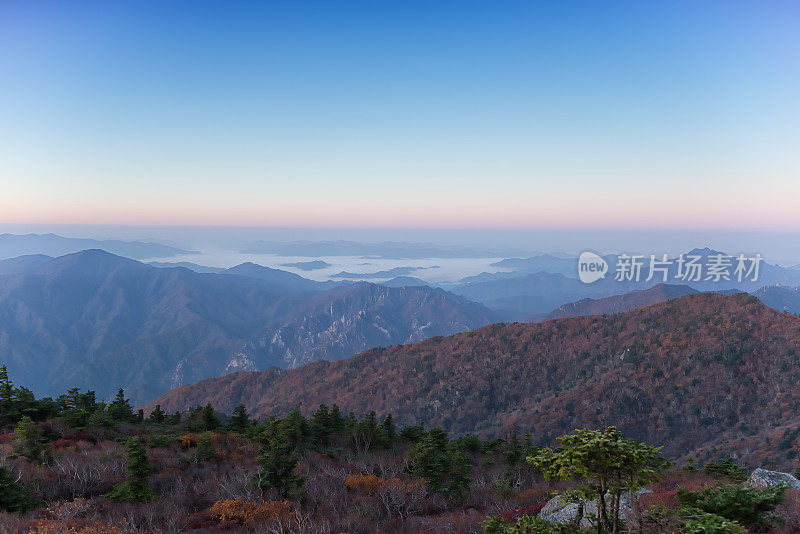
[0,234,196,260]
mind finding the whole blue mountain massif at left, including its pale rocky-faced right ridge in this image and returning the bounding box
[0,250,493,403]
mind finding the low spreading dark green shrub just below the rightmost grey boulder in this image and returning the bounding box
[678,484,786,527]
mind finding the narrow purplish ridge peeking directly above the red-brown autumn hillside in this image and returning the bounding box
[546,284,697,319]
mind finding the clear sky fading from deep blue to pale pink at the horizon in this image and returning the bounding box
[0,0,800,233]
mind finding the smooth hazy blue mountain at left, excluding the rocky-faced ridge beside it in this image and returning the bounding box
[0,250,296,401]
